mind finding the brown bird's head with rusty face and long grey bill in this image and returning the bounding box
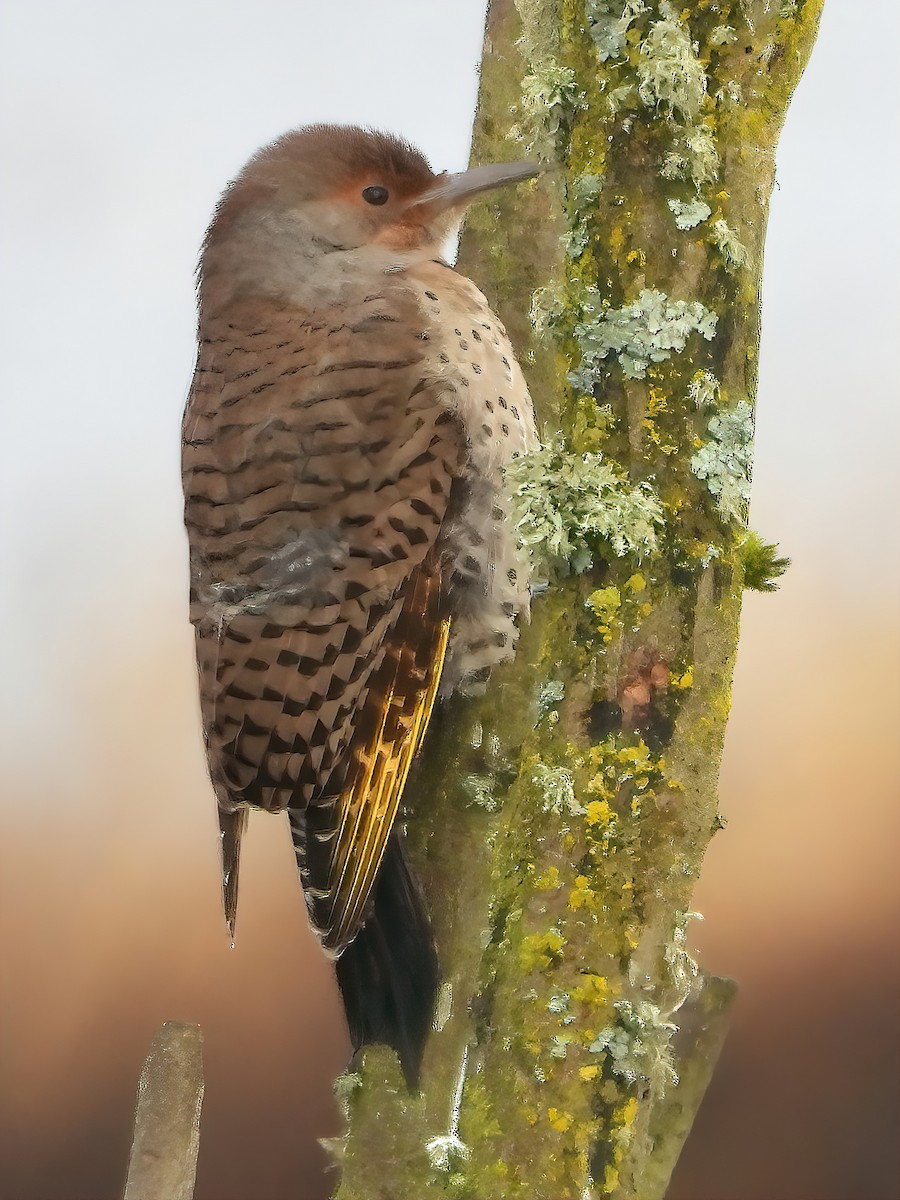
[204,125,540,300]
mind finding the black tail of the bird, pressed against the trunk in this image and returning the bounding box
[335,832,440,1088]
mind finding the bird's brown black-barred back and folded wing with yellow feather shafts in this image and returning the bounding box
[184,285,463,937]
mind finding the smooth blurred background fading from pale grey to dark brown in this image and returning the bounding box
[0,0,900,1200]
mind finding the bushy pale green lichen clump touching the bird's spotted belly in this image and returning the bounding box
[505,440,662,572]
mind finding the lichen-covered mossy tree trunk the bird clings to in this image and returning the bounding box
[334,0,822,1200]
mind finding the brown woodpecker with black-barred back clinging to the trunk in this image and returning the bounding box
[182,125,540,1086]
